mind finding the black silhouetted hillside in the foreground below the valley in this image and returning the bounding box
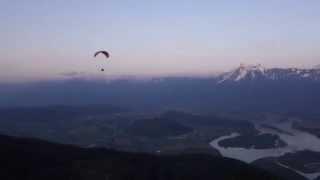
[0,136,276,180]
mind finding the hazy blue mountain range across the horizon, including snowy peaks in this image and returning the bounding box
[0,65,320,115]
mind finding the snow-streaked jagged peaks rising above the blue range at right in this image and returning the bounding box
[218,64,320,83]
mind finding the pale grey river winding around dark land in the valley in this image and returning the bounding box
[210,121,320,179]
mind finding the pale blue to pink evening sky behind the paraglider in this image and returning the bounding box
[0,0,320,81]
